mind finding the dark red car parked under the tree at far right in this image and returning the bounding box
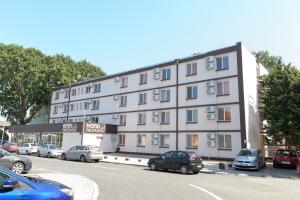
[273,149,299,168]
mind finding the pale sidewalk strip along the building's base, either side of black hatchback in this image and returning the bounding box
[101,153,300,180]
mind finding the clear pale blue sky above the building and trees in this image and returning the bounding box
[0,0,300,74]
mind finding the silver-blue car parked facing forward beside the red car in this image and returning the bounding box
[233,149,266,170]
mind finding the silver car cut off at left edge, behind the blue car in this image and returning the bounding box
[0,149,32,174]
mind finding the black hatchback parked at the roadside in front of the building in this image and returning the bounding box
[148,151,203,174]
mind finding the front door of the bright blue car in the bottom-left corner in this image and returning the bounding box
[0,172,23,200]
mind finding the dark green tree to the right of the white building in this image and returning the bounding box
[255,52,300,147]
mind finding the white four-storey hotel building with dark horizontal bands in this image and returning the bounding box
[49,43,262,158]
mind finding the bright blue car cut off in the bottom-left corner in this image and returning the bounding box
[0,167,74,200]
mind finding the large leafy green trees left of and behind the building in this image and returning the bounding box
[0,44,105,124]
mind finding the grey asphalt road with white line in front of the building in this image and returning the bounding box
[28,156,300,200]
